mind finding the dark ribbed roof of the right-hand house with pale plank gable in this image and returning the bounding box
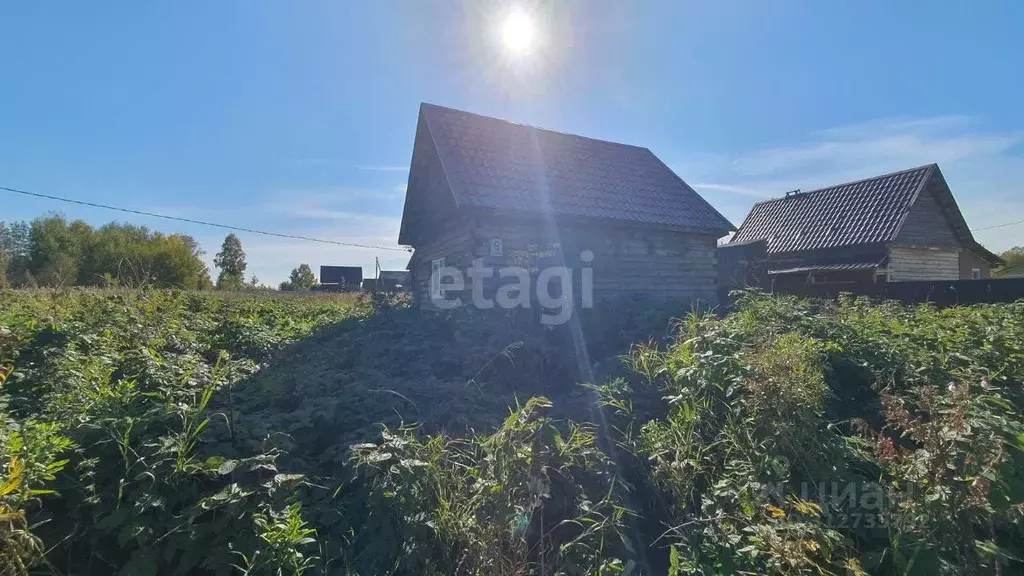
[731,164,998,262]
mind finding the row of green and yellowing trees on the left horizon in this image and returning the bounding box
[0,213,316,290]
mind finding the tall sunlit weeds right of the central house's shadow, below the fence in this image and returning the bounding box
[604,293,1024,575]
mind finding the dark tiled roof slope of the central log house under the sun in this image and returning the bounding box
[421,104,734,236]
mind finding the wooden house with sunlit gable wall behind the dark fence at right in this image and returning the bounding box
[730,164,1000,283]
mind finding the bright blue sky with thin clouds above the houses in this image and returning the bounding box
[0,0,1024,283]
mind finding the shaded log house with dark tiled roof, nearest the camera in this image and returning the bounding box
[398,104,733,305]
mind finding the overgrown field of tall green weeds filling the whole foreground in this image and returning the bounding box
[0,291,1024,575]
